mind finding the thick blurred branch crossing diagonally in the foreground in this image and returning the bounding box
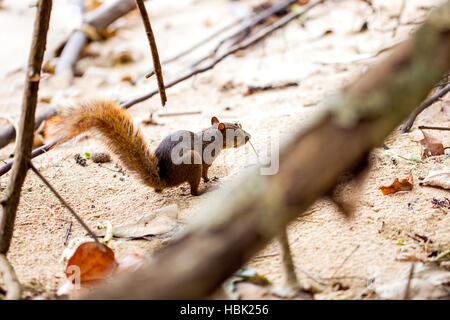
[83,2,450,299]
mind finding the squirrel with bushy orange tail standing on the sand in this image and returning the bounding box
[56,100,251,195]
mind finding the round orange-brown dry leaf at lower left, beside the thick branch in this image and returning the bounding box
[65,241,117,286]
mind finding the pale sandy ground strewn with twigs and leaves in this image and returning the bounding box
[0,0,450,299]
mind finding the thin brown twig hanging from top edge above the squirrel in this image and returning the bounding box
[136,0,167,106]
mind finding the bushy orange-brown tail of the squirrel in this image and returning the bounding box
[57,100,163,189]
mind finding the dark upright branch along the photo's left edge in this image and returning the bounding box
[0,0,52,298]
